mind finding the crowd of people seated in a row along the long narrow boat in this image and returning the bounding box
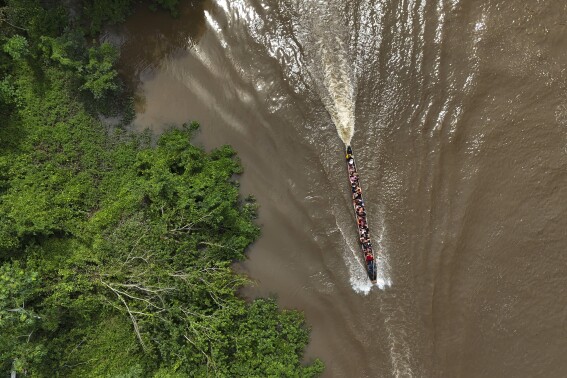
[346,148,375,276]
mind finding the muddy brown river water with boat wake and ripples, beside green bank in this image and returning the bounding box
[107,0,567,377]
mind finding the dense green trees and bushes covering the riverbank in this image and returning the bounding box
[0,0,323,377]
